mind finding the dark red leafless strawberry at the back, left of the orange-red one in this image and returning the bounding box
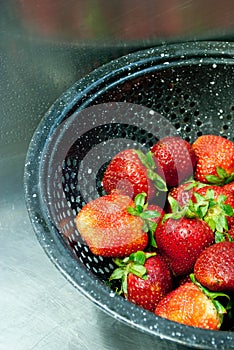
[151,136,196,187]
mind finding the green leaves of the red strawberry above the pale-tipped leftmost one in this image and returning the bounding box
[134,150,168,192]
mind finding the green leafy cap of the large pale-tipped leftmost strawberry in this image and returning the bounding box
[127,192,160,247]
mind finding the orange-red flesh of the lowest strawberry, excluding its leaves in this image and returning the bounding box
[155,282,226,330]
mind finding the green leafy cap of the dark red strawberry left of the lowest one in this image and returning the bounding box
[109,250,156,296]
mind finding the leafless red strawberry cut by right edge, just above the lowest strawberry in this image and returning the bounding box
[194,242,234,292]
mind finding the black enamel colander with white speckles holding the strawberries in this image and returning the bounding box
[25,42,234,349]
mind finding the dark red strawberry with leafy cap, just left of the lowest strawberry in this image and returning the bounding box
[110,251,173,312]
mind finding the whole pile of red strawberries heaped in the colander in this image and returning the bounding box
[76,135,234,330]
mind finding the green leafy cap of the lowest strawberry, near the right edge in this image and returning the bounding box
[189,273,230,326]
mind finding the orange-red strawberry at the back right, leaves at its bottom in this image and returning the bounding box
[192,135,234,185]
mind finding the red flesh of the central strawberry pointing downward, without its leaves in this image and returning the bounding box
[155,214,214,276]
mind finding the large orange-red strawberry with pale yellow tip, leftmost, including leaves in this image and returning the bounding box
[75,191,160,257]
